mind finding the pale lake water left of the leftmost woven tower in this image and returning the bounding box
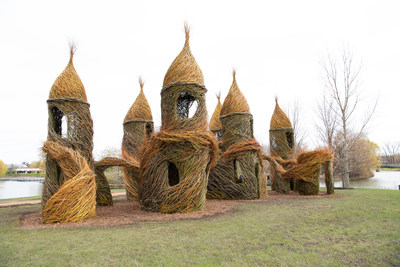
[0,181,43,199]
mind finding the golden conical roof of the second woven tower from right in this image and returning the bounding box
[221,70,250,116]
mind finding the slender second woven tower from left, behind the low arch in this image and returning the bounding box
[122,77,154,200]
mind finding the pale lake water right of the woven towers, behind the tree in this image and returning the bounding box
[320,171,400,190]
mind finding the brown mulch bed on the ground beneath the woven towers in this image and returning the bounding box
[20,191,340,229]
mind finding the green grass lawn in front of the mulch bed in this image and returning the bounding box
[0,189,400,266]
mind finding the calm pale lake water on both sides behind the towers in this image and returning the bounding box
[0,171,400,199]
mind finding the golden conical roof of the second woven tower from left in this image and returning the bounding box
[124,77,153,122]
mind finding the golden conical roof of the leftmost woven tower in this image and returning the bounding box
[49,44,87,102]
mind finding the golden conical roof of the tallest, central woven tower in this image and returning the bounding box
[163,23,204,87]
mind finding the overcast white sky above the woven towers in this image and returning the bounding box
[0,0,400,164]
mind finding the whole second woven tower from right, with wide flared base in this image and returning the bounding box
[207,72,267,199]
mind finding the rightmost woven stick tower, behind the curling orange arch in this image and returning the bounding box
[269,98,294,194]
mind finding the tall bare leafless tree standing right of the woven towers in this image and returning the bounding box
[320,49,377,191]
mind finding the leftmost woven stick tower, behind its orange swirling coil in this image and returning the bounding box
[42,44,112,210]
